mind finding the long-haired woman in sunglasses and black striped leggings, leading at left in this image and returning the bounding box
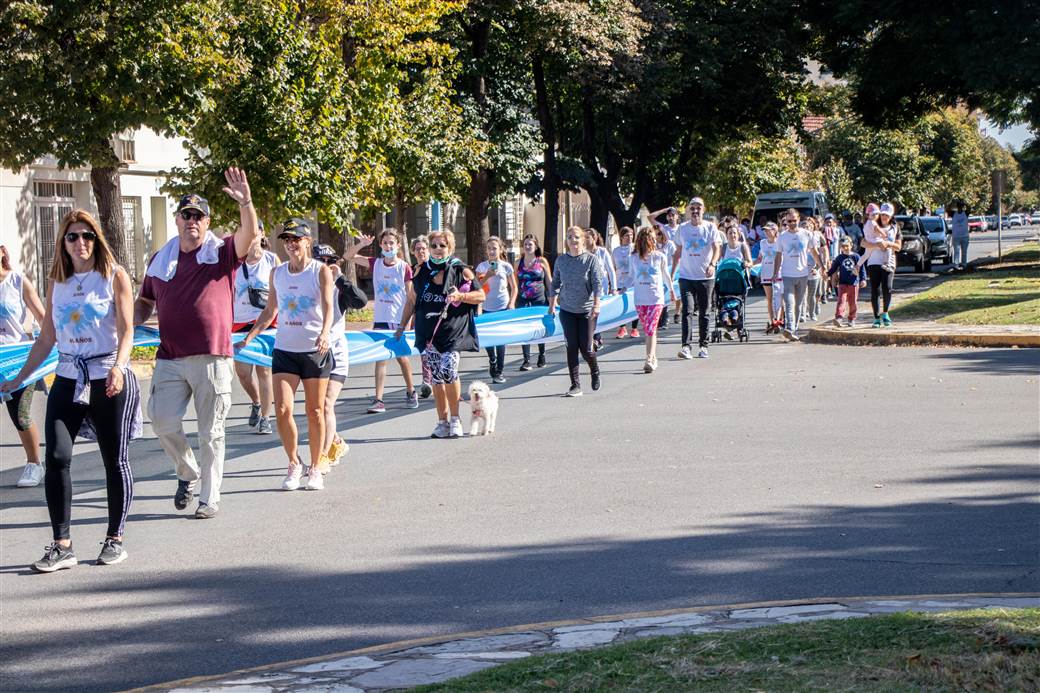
[0,209,140,572]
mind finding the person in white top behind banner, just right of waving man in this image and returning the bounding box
[231,232,282,435]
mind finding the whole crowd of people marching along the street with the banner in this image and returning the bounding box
[0,175,901,572]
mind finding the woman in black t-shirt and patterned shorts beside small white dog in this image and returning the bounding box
[394,229,485,438]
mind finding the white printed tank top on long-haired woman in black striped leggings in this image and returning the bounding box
[51,270,119,380]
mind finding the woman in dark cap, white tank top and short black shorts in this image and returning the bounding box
[239,219,335,491]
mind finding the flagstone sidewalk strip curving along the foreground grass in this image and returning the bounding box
[129,594,1040,693]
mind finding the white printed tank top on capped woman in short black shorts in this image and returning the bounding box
[270,260,332,354]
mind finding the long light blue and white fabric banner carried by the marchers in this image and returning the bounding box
[0,289,648,385]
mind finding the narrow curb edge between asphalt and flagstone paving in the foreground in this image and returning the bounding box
[124,592,1040,693]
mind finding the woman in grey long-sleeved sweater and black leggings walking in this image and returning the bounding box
[549,226,603,397]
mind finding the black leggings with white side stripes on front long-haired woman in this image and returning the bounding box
[44,369,140,540]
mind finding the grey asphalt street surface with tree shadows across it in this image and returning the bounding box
[0,225,1040,691]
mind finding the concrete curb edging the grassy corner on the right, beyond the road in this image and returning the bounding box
[806,324,1040,349]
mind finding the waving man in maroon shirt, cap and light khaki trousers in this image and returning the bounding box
[134,168,260,511]
